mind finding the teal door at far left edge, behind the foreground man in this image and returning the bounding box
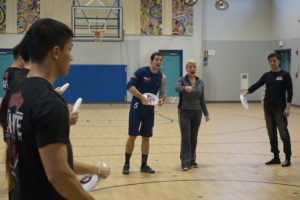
[0,49,14,97]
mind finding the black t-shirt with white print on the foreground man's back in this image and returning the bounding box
[5,77,73,200]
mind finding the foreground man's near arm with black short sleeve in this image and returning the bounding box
[31,96,94,200]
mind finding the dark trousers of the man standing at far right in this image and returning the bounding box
[264,104,292,158]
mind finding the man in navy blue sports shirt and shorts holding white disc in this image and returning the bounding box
[122,52,166,174]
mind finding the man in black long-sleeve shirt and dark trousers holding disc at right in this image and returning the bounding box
[243,53,293,167]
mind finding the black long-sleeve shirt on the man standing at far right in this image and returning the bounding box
[248,70,293,105]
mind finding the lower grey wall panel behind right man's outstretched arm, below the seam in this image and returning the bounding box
[203,40,270,102]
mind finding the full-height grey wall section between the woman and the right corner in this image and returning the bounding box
[203,0,272,102]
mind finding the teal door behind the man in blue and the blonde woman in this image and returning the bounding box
[159,50,183,97]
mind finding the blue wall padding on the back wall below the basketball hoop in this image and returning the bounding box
[54,64,127,103]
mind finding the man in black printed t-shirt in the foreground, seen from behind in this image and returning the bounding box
[0,19,107,200]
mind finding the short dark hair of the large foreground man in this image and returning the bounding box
[22,18,73,63]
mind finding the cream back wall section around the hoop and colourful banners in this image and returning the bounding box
[0,0,203,100]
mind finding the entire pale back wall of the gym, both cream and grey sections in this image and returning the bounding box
[0,0,300,105]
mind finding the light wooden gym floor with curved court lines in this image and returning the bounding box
[0,103,300,200]
